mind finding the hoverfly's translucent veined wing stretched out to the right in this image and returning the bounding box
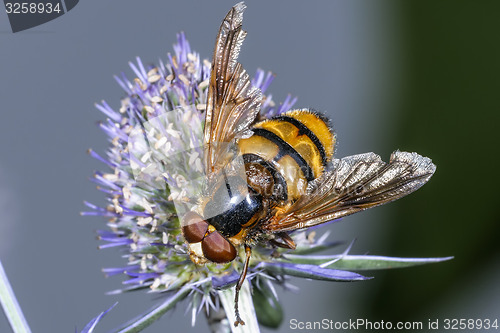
[263,151,436,232]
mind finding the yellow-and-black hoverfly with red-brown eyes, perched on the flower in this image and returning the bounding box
[181,3,435,326]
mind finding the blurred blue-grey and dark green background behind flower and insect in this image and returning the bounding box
[0,0,500,332]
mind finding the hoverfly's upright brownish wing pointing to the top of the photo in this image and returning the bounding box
[203,2,262,175]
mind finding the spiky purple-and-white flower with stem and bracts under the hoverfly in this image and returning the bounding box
[83,4,452,332]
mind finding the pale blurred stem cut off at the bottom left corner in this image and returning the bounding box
[0,262,31,333]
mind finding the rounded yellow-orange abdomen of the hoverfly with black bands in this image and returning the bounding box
[238,110,335,203]
